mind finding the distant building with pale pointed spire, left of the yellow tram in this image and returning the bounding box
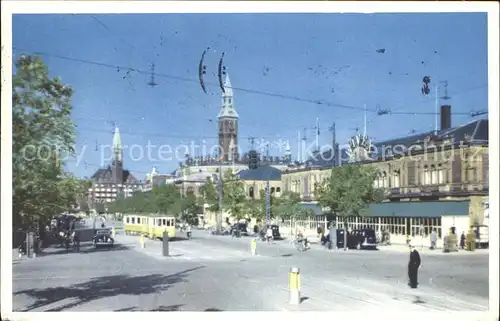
[88,127,143,205]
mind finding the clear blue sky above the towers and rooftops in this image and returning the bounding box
[13,13,488,179]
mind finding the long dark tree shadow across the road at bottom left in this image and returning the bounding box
[13,266,204,312]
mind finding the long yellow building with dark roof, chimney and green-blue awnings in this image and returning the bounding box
[282,106,489,242]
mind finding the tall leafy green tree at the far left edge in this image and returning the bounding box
[12,56,77,227]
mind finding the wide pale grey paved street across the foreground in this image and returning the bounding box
[13,231,488,311]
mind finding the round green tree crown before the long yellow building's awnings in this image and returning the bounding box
[315,164,380,216]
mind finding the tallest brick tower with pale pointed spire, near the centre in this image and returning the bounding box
[217,74,239,162]
